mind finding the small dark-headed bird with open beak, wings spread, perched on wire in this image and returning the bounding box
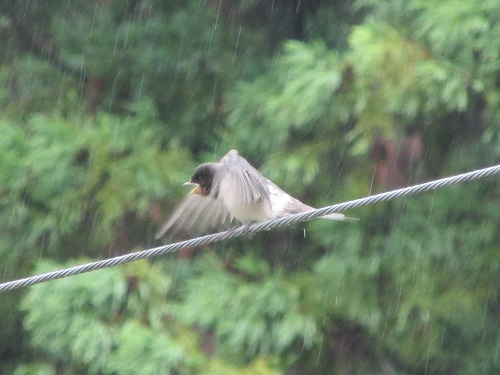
[156,150,357,239]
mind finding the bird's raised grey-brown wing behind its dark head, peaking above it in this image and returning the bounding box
[212,150,269,204]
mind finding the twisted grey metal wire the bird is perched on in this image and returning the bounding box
[0,165,500,293]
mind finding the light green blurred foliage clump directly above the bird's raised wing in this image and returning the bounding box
[228,41,348,152]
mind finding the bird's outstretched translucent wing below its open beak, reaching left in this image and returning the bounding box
[156,194,233,239]
